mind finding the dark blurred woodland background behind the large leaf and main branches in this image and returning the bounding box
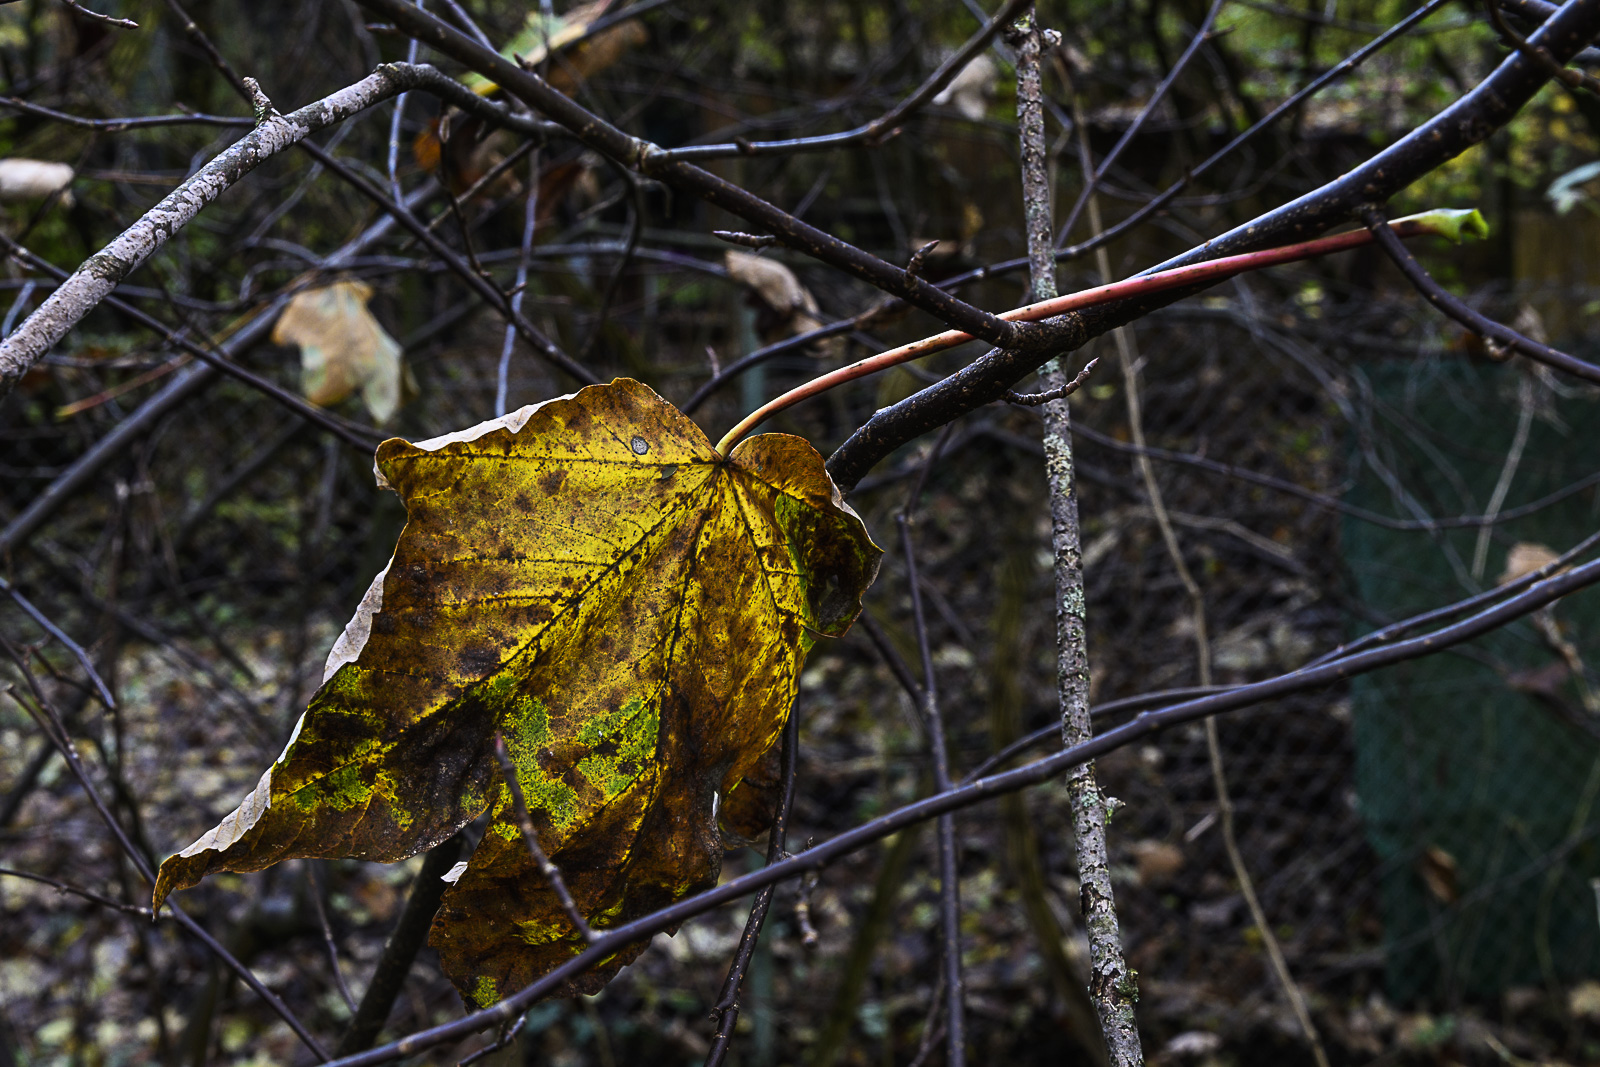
[0,0,1600,1067]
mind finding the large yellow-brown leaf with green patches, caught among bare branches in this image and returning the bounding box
[155,379,878,1005]
